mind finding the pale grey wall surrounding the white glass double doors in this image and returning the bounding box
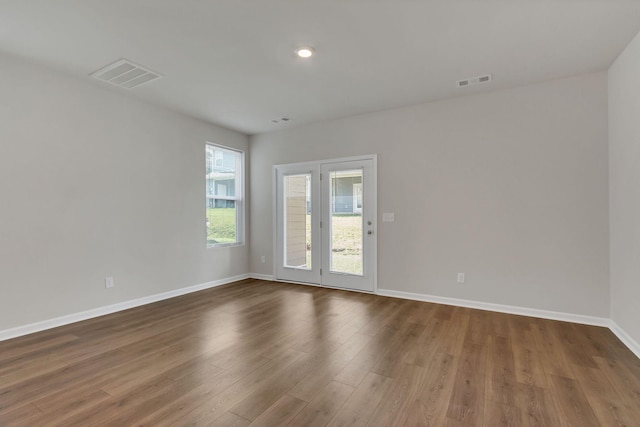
[251,73,609,318]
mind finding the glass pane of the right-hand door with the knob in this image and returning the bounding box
[330,169,363,276]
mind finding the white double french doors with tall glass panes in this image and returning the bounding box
[275,156,377,292]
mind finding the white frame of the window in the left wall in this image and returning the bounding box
[204,142,246,249]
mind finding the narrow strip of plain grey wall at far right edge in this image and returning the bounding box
[609,35,640,349]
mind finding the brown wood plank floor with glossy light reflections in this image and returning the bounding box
[0,280,640,427]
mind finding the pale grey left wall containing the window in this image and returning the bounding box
[0,56,248,331]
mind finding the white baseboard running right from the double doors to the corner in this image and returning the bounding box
[377,289,611,327]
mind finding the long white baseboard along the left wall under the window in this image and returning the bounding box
[0,274,250,341]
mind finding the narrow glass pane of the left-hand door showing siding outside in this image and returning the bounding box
[283,174,311,270]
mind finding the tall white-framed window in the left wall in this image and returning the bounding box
[205,144,244,247]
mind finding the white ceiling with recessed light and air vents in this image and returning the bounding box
[0,0,640,134]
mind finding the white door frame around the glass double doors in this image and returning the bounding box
[271,154,378,294]
